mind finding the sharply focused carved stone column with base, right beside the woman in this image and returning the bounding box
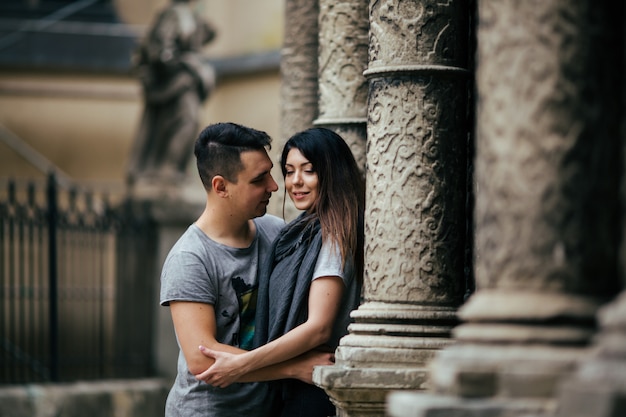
[314,0,469,417]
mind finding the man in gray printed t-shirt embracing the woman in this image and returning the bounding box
[161,123,330,417]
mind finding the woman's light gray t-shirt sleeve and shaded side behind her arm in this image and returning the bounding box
[311,237,361,350]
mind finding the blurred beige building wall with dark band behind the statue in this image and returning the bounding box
[0,0,283,207]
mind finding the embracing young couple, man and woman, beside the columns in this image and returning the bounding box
[161,123,364,417]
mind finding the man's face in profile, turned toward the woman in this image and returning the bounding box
[228,150,278,219]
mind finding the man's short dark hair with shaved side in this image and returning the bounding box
[194,123,272,190]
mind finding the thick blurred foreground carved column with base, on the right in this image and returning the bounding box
[389,0,624,417]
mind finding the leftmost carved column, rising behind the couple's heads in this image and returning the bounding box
[271,0,319,219]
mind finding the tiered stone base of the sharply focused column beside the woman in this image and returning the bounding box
[313,302,456,417]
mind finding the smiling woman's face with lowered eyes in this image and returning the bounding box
[285,148,319,211]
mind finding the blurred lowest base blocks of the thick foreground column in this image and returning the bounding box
[386,343,588,417]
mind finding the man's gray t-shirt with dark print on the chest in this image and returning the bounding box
[161,215,285,417]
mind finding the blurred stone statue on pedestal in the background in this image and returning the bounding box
[127,0,215,185]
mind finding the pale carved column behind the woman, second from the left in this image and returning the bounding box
[315,0,369,171]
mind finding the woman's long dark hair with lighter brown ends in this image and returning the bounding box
[281,128,365,280]
